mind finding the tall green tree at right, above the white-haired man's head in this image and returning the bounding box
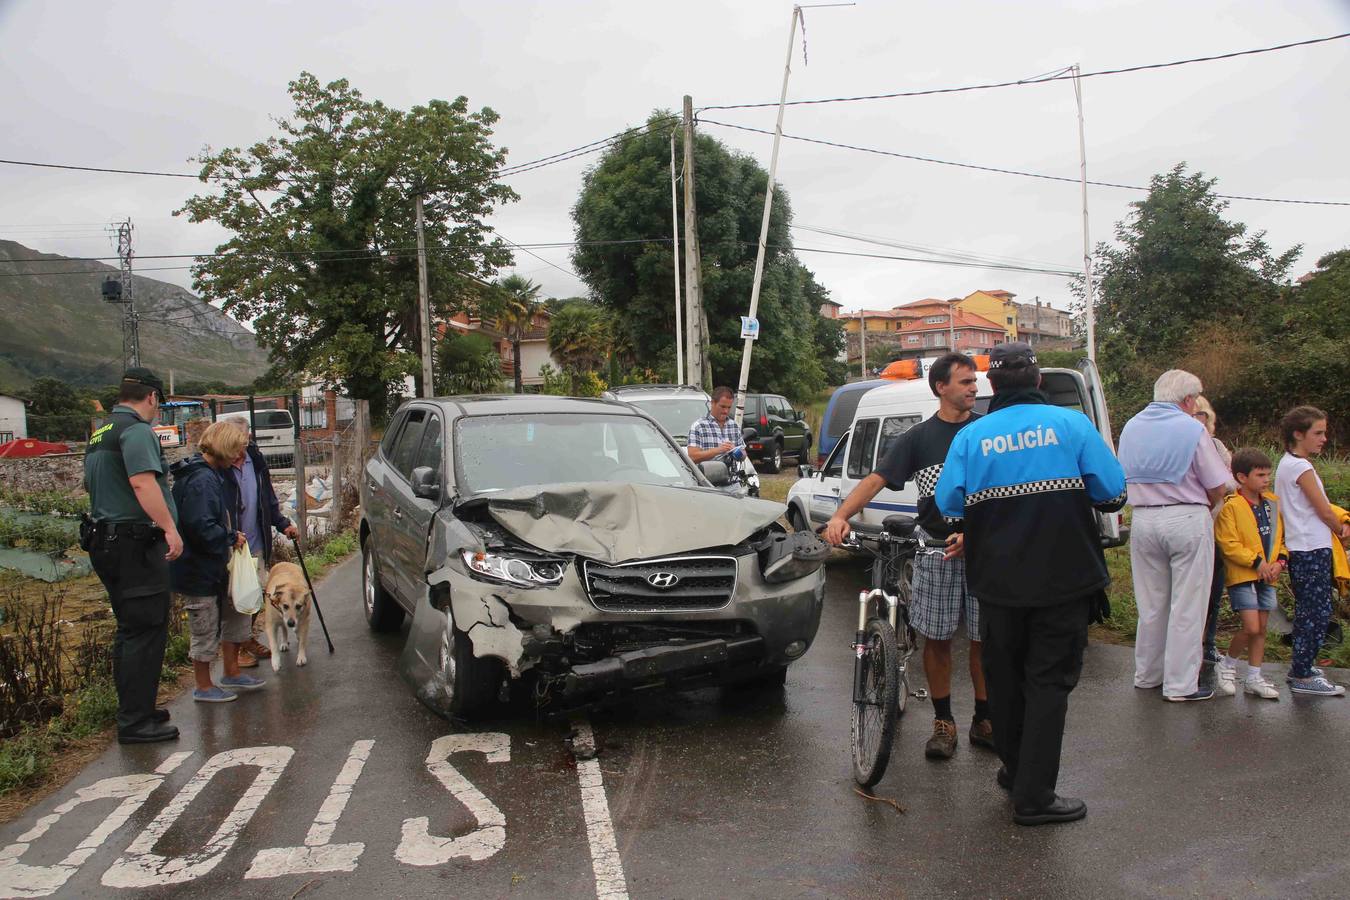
[1079,163,1300,421]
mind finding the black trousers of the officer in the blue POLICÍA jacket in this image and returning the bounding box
[980,596,1091,808]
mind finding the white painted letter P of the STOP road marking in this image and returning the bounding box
[0,750,192,897]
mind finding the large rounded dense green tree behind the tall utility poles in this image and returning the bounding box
[572,111,825,397]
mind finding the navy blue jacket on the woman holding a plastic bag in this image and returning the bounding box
[169,453,239,596]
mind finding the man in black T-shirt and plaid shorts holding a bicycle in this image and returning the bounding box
[825,354,994,760]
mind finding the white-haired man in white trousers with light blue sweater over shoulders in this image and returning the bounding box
[1119,368,1231,702]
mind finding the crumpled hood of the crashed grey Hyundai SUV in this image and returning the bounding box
[486,482,783,563]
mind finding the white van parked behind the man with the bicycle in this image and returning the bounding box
[787,360,1129,546]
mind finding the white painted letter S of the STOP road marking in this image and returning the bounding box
[394,731,510,866]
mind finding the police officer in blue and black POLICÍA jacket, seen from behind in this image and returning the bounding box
[936,341,1125,824]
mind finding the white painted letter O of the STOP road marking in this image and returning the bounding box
[103,746,296,888]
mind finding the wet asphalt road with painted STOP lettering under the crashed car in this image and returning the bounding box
[0,560,1350,897]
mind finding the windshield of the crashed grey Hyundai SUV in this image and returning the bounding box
[455,416,698,494]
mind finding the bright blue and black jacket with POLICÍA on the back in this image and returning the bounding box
[936,391,1125,607]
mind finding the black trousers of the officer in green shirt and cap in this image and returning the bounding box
[89,530,169,734]
